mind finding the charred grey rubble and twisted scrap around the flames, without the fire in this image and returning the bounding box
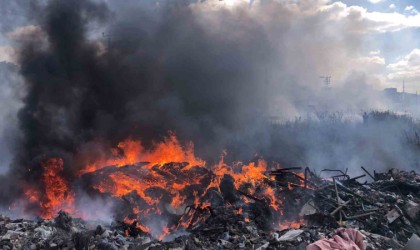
[0,168,420,250]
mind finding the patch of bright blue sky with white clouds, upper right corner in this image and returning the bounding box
[336,0,420,92]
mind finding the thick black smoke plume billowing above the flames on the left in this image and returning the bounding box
[4,0,272,204]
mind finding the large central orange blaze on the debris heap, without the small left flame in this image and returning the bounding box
[82,139,280,238]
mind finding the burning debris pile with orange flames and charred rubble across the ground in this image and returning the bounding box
[0,147,420,249]
